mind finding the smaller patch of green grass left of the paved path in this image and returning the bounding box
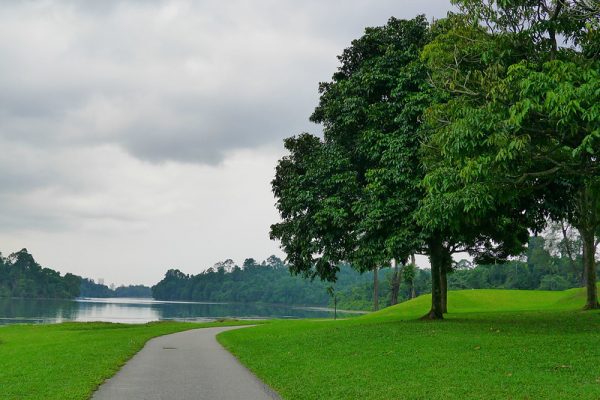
[0,321,256,400]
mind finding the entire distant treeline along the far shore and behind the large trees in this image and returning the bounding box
[0,233,583,304]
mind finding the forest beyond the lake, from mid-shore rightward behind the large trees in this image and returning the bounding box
[152,231,596,310]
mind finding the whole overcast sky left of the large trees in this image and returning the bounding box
[0,0,450,285]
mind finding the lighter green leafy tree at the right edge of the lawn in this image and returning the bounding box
[424,0,600,308]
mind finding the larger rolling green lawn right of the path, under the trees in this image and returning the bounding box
[218,289,600,399]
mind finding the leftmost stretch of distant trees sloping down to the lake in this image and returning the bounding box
[0,249,152,299]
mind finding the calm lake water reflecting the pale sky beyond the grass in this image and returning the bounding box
[0,298,364,325]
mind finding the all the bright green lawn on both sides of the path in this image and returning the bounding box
[0,289,600,400]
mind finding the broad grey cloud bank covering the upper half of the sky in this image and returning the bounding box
[0,0,448,164]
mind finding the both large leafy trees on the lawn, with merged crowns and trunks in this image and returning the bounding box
[271,0,600,319]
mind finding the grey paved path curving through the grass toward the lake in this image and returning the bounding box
[92,327,279,400]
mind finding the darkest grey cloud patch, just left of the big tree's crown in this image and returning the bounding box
[123,93,306,164]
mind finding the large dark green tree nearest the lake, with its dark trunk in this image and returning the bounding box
[271,17,527,318]
